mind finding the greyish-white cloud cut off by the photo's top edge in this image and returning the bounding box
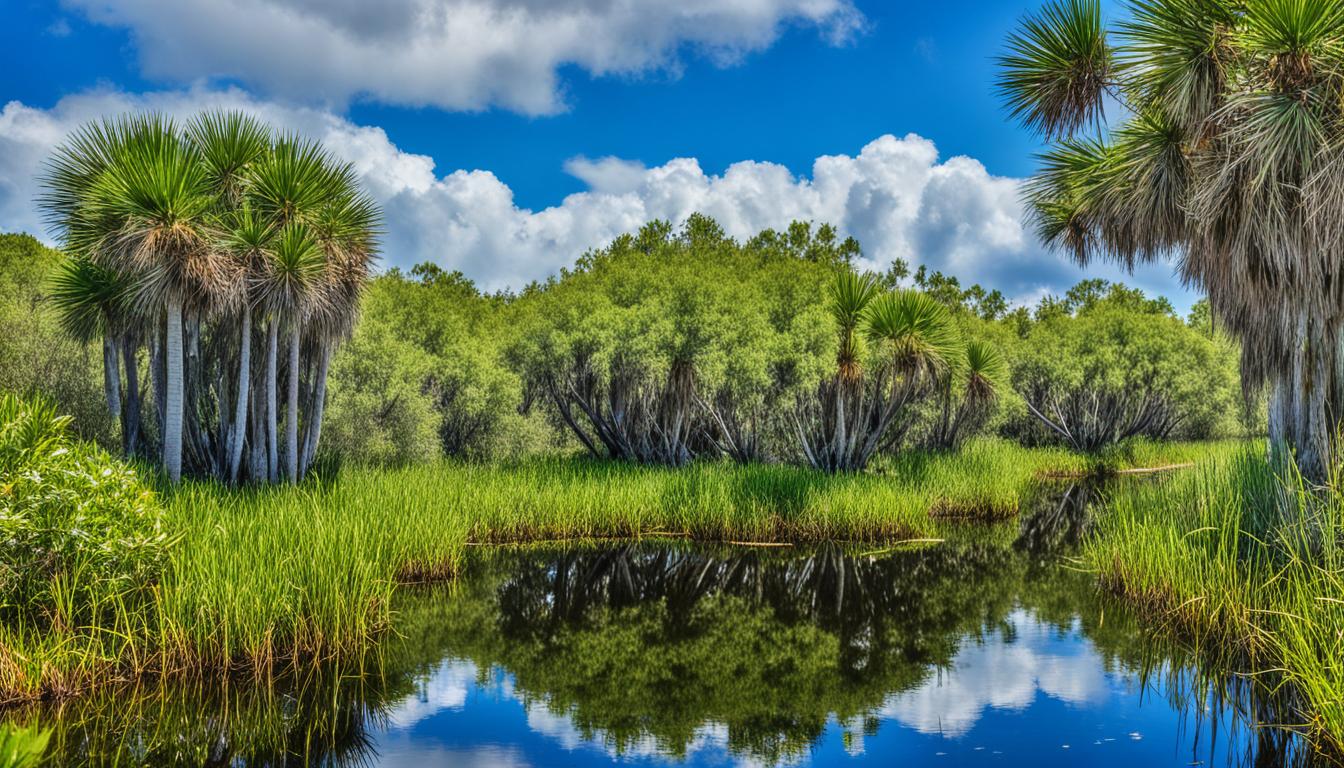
[66,0,864,114]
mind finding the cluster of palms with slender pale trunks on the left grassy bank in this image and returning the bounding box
[39,112,380,483]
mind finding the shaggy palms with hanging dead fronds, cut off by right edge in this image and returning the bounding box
[1000,0,1344,482]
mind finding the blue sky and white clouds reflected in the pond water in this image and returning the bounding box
[375,599,1245,768]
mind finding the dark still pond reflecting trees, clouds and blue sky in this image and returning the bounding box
[9,487,1309,768]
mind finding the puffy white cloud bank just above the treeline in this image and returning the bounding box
[0,87,1188,305]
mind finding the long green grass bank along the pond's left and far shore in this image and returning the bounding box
[0,440,1228,702]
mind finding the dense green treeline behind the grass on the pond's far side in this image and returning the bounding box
[0,217,1241,471]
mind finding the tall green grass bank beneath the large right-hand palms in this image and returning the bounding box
[1086,448,1344,756]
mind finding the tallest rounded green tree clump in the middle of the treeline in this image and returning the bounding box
[508,217,845,465]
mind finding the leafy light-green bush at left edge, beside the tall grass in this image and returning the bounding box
[0,394,168,627]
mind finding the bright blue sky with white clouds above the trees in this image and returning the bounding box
[0,0,1195,308]
